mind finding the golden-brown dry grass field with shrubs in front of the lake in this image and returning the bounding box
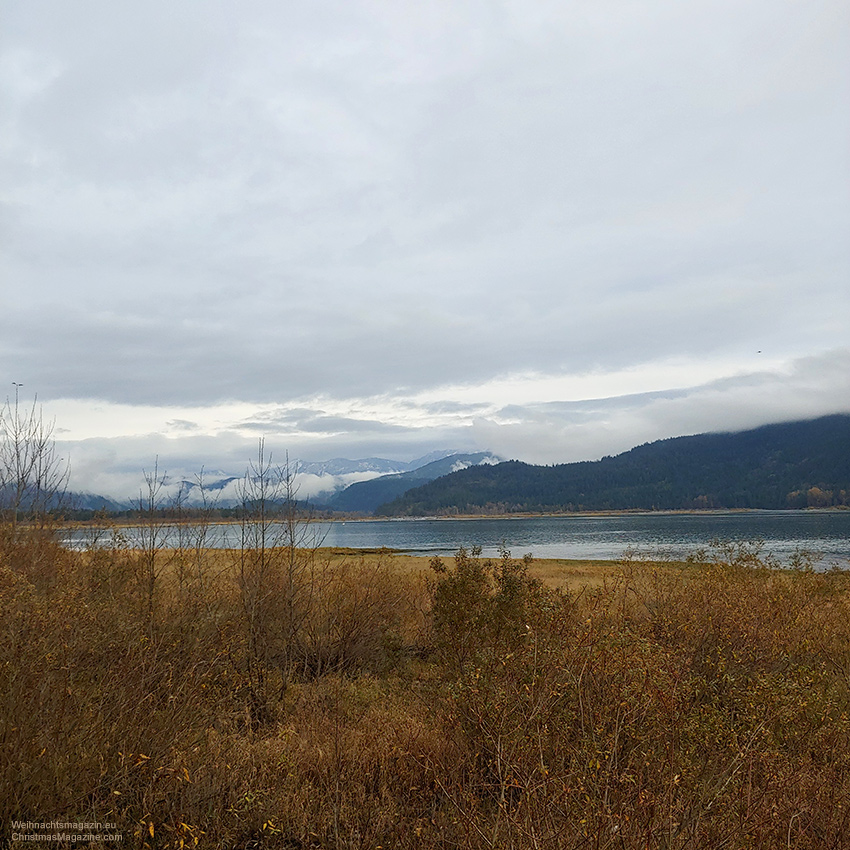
[0,528,850,850]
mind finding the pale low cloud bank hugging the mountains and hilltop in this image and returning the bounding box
[59,348,850,499]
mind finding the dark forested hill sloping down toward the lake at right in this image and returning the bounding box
[376,414,850,516]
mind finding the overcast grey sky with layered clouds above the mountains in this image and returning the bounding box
[0,0,850,491]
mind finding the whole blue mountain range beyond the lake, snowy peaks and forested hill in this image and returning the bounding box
[63,414,850,516]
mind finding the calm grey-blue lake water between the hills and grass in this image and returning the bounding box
[68,511,850,567]
